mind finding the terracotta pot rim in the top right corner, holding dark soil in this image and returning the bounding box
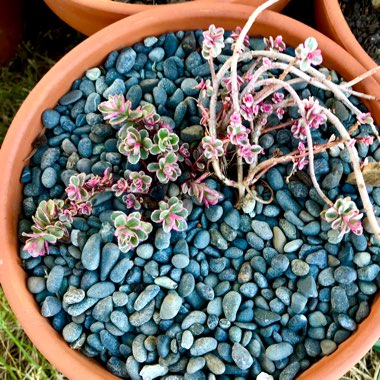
[314,0,380,83]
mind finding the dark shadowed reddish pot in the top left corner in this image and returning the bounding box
[0,0,23,65]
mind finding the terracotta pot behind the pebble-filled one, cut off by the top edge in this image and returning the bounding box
[44,0,290,36]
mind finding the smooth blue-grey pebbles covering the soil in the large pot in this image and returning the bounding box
[19,31,380,380]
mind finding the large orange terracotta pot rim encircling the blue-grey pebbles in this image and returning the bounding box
[0,3,380,380]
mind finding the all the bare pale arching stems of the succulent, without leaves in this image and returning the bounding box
[208,0,380,214]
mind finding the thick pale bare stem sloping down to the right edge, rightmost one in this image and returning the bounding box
[323,109,380,240]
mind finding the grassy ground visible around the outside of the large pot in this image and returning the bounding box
[0,0,380,380]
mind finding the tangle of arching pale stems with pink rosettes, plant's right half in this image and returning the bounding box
[199,0,380,240]
